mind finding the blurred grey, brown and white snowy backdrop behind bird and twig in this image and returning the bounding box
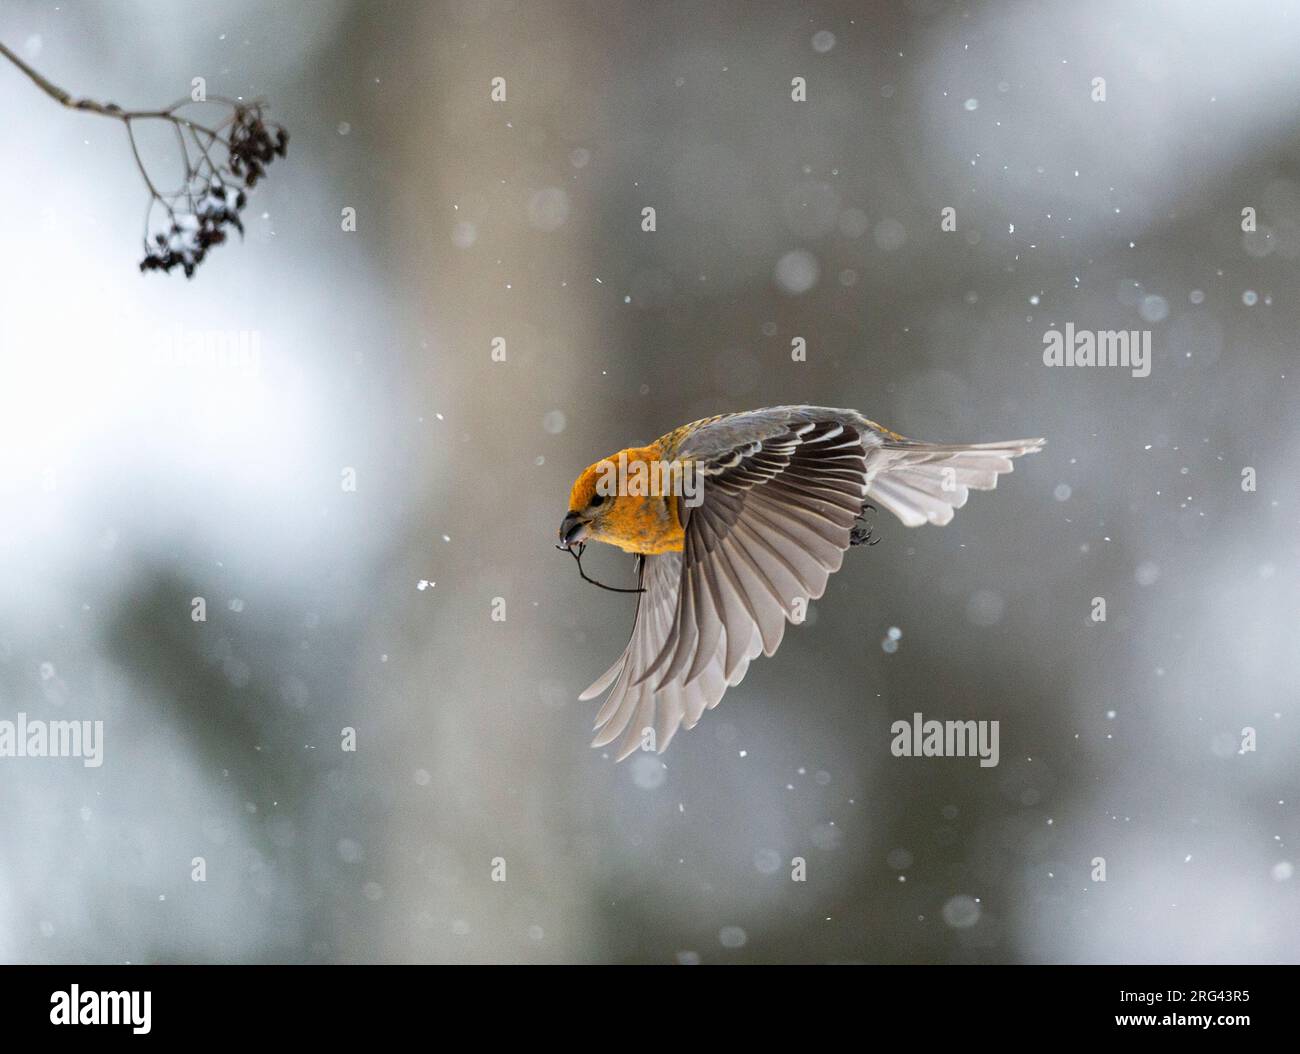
[0,0,1300,963]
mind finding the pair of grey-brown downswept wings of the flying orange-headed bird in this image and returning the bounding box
[582,415,867,760]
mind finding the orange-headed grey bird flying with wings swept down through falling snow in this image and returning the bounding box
[559,405,1044,760]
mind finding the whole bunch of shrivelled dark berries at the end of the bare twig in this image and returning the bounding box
[140,105,289,278]
